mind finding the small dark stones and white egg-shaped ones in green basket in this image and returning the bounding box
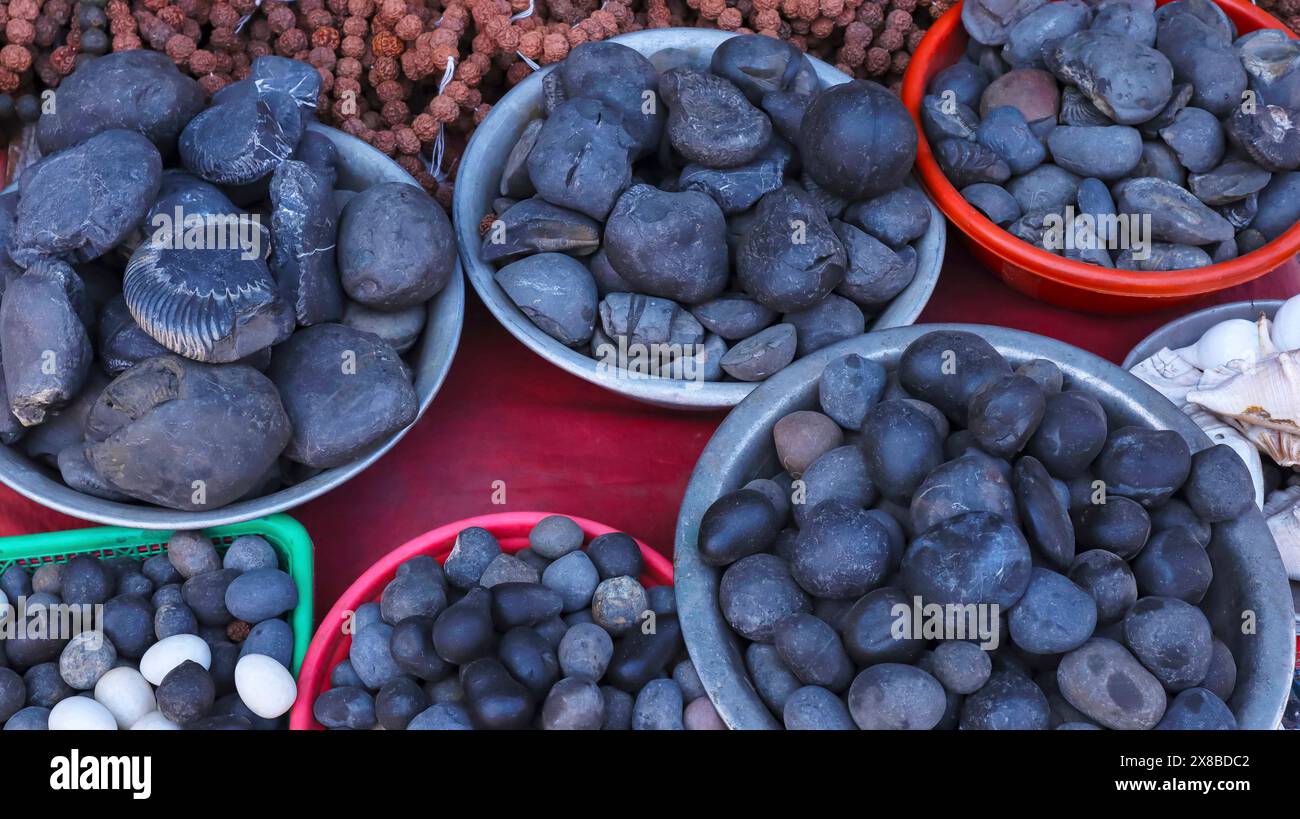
[0,532,299,731]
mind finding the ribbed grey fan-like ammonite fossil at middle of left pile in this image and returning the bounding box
[122,242,295,363]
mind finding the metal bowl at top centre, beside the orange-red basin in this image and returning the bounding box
[452,29,948,410]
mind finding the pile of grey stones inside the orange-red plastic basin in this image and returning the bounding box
[922,0,1300,270]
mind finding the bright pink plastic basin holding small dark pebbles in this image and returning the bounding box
[289,512,672,731]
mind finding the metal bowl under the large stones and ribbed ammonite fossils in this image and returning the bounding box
[0,124,465,529]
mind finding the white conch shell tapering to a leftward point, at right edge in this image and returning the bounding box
[1187,351,1300,433]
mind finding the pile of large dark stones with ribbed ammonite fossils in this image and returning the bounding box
[0,51,456,511]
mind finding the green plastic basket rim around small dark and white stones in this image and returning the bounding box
[0,515,315,677]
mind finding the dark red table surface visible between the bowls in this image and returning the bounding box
[0,235,1300,612]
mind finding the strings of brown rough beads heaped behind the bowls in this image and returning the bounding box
[0,0,941,195]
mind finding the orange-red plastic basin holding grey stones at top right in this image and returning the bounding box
[902,0,1300,313]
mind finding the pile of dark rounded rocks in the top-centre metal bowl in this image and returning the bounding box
[481,35,931,381]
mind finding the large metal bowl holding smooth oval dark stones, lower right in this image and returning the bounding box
[673,325,1295,728]
